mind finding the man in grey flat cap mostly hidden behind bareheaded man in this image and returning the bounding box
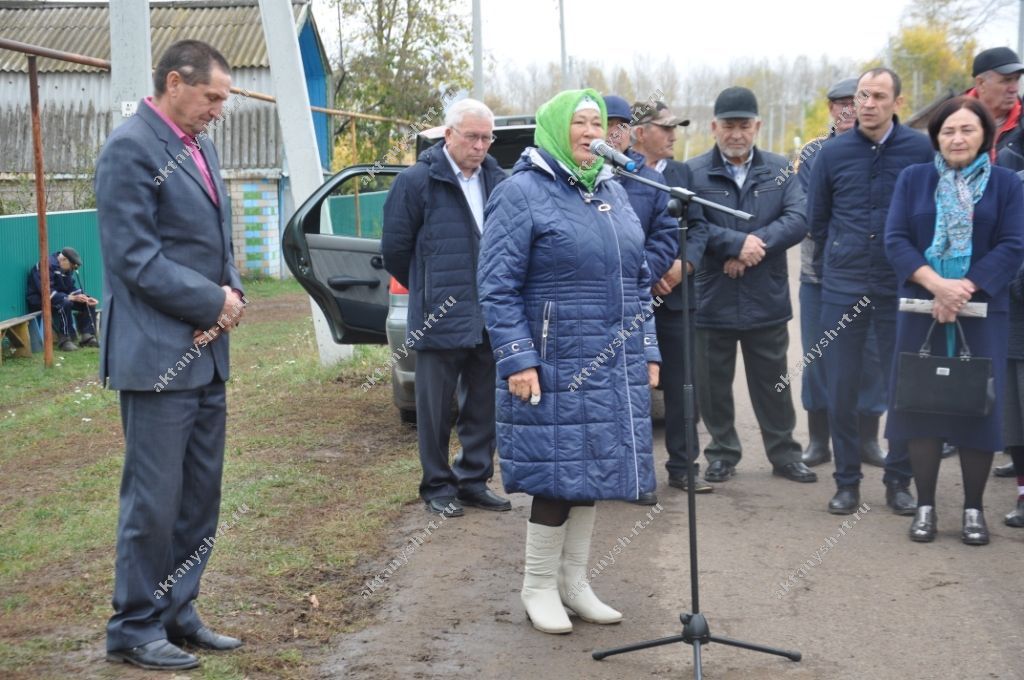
[797,78,886,467]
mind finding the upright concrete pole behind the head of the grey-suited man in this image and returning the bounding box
[111,0,153,128]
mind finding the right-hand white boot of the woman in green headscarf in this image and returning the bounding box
[558,506,623,624]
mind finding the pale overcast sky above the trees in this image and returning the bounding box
[313,0,1018,74]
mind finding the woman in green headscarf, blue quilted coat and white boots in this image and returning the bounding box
[478,89,660,633]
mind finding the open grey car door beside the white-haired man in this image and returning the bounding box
[282,165,406,344]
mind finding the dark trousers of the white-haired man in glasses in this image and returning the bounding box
[416,342,495,501]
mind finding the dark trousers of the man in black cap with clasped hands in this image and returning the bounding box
[696,324,802,466]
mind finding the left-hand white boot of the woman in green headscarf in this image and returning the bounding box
[520,521,572,633]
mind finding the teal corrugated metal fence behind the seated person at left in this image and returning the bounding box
[0,210,103,320]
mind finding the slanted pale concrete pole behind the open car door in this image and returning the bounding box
[259,0,352,366]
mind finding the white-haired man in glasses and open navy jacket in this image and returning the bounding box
[381,99,512,517]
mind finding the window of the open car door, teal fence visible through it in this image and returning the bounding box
[321,174,395,239]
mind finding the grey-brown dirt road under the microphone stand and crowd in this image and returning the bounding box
[321,249,1024,680]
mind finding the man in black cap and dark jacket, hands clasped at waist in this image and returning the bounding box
[686,87,817,482]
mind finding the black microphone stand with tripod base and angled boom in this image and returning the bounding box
[592,167,801,680]
